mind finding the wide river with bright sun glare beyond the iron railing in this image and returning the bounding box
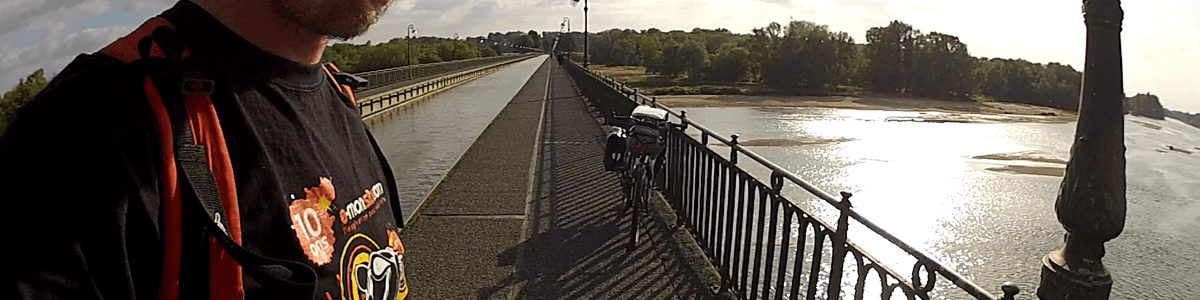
[688,108,1200,299]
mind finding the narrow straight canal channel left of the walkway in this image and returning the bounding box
[364,55,546,221]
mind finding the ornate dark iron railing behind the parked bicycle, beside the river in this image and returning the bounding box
[560,59,1019,300]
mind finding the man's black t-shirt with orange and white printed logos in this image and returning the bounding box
[0,1,407,299]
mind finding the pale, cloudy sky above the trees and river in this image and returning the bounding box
[0,0,1200,113]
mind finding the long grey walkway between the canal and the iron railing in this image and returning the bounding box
[403,59,702,299]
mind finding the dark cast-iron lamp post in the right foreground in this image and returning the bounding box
[1038,0,1126,300]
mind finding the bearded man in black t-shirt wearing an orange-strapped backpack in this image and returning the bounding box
[0,0,408,299]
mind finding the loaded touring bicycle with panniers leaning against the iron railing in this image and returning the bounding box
[605,106,671,252]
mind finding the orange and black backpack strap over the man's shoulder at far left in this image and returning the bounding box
[100,17,316,300]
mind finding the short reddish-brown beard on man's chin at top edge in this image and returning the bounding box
[272,0,391,40]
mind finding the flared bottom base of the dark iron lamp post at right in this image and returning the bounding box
[1038,250,1112,300]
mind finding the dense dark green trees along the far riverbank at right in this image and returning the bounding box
[588,20,1082,110]
